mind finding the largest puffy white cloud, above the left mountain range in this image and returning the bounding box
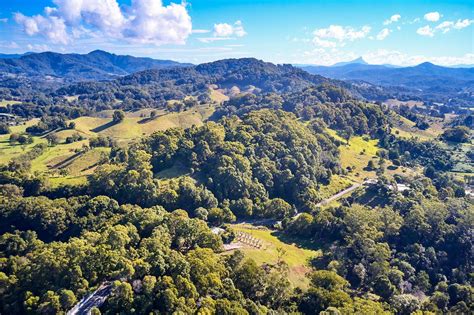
[15,0,192,45]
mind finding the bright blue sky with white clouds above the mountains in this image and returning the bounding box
[0,0,474,66]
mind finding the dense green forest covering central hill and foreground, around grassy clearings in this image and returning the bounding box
[0,59,474,314]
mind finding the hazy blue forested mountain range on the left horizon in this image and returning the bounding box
[0,50,189,81]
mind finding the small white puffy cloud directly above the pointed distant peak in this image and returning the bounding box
[313,25,371,48]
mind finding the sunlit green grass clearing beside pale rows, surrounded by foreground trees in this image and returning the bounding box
[226,224,322,288]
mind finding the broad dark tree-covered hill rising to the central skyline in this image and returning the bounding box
[54,58,388,109]
